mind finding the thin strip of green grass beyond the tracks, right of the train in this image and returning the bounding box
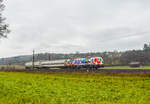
[101,66,150,69]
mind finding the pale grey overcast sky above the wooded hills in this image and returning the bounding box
[0,0,150,57]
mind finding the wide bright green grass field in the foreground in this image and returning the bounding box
[0,72,150,104]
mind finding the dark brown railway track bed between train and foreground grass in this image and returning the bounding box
[0,69,150,73]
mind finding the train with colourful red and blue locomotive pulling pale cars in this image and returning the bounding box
[25,57,104,69]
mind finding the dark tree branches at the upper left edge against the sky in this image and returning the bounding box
[0,0,10,38]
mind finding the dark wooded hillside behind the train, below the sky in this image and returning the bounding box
[0,44,150,65]
